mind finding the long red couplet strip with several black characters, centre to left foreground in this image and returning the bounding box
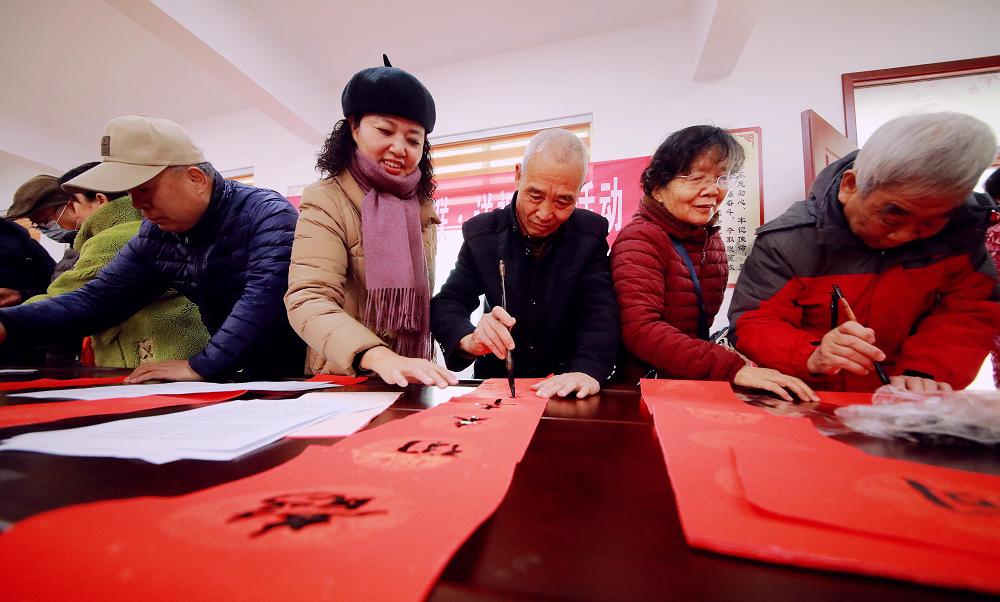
[0,378,545,600]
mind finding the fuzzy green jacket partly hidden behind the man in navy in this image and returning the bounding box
[28,196,208,368]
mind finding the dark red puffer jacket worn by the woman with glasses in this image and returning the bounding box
[611,198,745,380]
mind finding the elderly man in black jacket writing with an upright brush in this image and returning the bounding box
[431,129,619,398]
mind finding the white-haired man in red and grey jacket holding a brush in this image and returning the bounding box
[729,113,1000,391]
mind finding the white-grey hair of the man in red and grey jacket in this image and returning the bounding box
[854,113,997,197]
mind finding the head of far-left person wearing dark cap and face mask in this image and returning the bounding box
[6,175,79,280]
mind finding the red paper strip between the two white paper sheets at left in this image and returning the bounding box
[0,391,246,428]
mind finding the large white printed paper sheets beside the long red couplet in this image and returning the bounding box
[0,394,392,464]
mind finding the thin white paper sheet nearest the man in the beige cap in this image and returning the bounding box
[11,380,340,400]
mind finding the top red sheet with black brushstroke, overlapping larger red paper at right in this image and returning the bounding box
[733,442,1000,566]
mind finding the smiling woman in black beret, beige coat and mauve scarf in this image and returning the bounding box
[285,55,458,387]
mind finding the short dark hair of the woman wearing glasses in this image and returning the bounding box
[640,125,746,196]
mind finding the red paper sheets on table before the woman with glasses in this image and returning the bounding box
[642,381,1000,593]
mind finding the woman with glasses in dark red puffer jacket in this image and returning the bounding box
[611,125,818,401]
